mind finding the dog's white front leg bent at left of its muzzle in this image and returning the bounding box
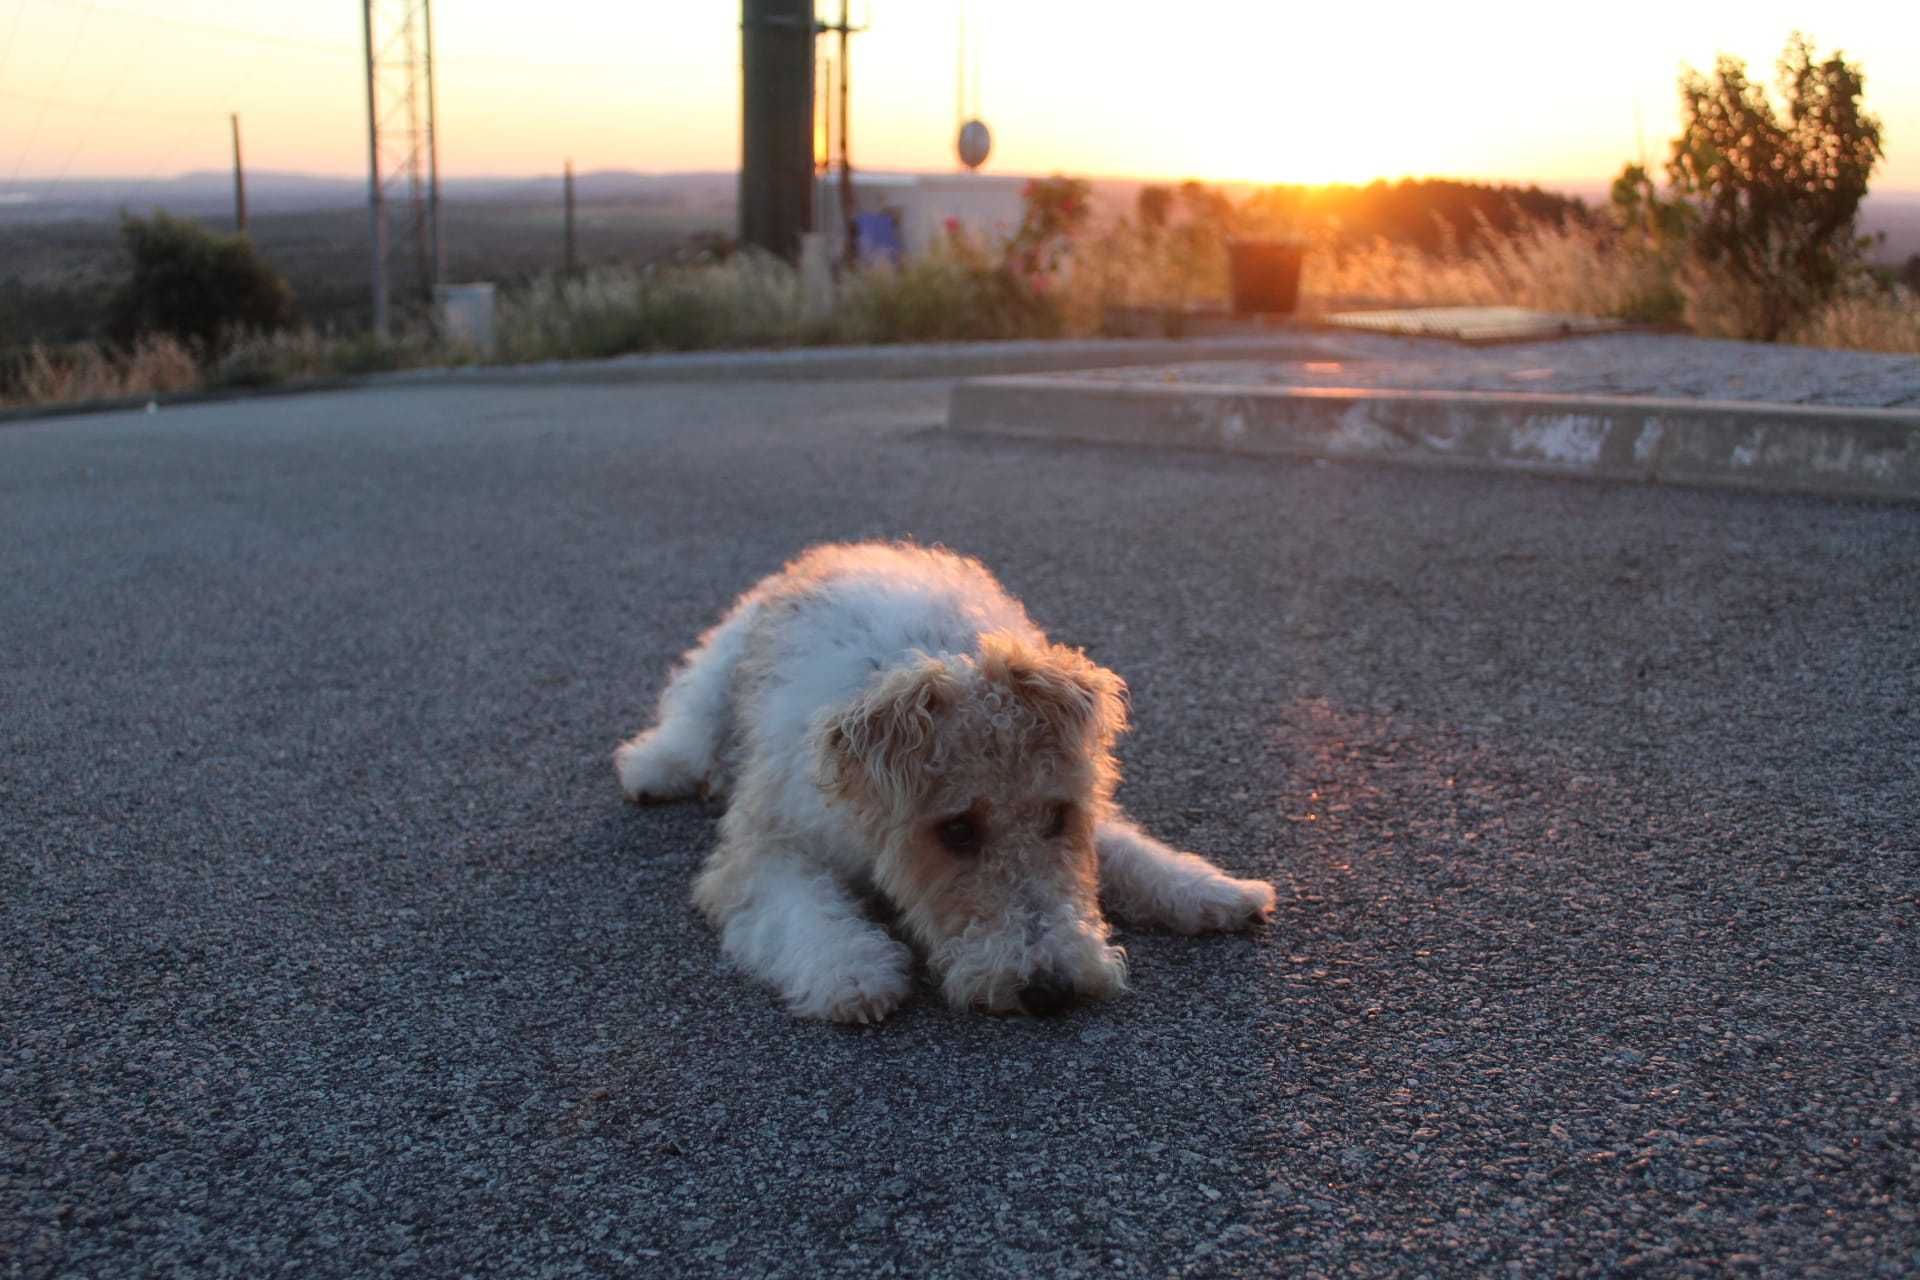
[693,841,912,1023]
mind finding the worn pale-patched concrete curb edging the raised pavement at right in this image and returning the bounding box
[947,376,1920,503]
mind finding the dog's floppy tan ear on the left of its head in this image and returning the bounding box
[816,658,960,812]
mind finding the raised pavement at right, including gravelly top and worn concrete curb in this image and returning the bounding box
[948,334,1920,501]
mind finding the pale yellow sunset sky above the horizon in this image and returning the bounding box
[0,0,1920,194]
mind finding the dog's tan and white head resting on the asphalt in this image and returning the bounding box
[814,635,1127,1013]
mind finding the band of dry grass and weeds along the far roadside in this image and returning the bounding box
[0,219,1920,405]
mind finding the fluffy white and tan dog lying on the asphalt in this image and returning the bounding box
[614,543,1275,1023]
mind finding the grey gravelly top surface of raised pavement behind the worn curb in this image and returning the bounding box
[1075,332,1920,409]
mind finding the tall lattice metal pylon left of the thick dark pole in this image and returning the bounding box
[361,0,445,334]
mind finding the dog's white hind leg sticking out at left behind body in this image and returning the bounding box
[612,603,758,802]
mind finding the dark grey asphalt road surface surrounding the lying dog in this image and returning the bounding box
[0,382,1920,1278]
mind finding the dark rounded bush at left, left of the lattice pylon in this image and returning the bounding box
[108,213,294,353]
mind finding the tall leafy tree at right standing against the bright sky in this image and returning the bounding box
[1667,31,1882,342]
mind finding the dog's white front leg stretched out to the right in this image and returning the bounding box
[1094,816,1275,933]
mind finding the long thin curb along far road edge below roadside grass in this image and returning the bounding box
[0,328,1325,424]
